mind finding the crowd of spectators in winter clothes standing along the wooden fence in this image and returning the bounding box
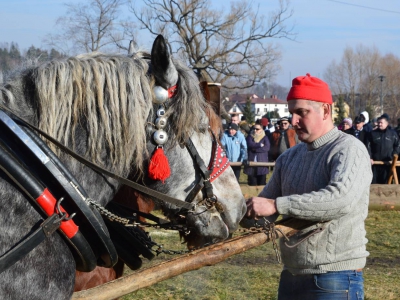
[221,111,400,185]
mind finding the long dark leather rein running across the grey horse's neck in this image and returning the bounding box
[0,105,194,210]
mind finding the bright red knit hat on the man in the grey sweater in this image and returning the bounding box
[286,73,333,104]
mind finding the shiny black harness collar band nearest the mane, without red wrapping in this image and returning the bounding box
[0,111,118,271]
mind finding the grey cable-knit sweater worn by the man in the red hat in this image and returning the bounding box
[259,127,372,274]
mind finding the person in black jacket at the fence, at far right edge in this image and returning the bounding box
[367,115,400,184]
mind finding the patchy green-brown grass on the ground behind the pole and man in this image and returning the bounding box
[122,171,400,300]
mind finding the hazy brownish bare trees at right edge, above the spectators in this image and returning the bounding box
[324,45,400,118]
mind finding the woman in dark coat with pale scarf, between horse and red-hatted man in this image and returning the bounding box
[244,123,270,186]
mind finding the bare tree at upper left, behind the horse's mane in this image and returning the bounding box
[45,0,134,53]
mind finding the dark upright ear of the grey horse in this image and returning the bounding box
[151,35,178,89]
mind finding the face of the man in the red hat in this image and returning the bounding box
[288,99,327,143]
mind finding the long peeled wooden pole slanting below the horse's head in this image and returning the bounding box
[72,219,314,300]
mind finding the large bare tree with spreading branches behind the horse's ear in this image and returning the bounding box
[131,0,295,88]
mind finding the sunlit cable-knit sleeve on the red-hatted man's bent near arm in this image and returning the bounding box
[276,146,372,221]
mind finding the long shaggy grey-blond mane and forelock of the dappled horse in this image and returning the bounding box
[2,52,207,175]
